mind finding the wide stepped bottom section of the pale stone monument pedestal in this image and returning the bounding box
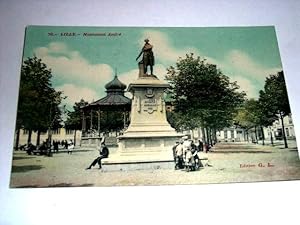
[102,132,181,171]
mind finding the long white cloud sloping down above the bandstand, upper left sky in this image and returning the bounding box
[34,42,113,85]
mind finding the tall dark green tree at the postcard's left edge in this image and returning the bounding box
[16,56,62,147]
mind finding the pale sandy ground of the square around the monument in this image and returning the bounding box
[10,143,300,187]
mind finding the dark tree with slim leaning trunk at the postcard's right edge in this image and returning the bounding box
[259,71,291,148]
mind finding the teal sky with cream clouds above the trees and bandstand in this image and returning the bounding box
[24,26,282,107]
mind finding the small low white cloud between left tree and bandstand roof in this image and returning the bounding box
[56,83,100,107]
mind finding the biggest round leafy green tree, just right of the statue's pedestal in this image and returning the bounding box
[166,53,245,143]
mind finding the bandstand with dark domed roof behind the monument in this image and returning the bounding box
[81,75,131,148]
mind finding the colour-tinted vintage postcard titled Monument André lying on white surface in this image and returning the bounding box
[10,26,300,188]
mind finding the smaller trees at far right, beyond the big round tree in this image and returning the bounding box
[235,71,291,148]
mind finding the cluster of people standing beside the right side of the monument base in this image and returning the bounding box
[173,136,208,171]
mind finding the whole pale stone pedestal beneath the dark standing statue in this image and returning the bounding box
[103,75,183,169]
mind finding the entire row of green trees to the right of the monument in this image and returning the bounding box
[166,54,290,147]
